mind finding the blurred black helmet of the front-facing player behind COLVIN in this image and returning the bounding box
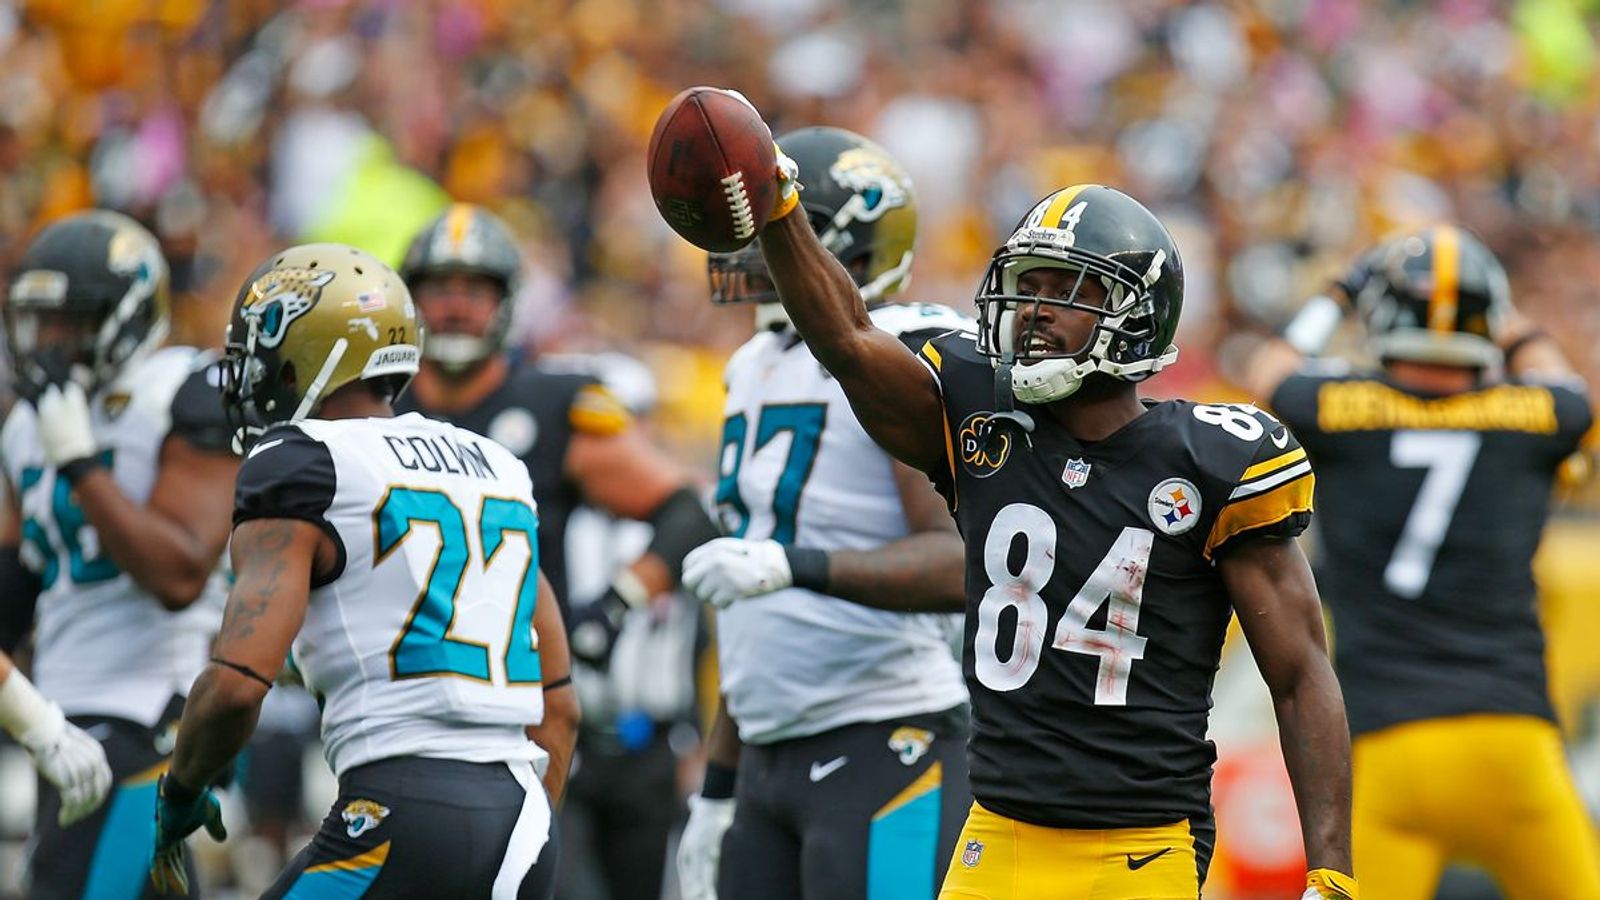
[400,203,522,372]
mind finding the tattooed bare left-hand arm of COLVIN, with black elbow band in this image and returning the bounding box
[170,519,336,791]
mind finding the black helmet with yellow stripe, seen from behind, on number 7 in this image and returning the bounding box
[1339,224,1510,368]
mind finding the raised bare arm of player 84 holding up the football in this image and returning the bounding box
[760,204,946,472]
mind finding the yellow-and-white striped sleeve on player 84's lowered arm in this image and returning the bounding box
[1203,407,1317,560]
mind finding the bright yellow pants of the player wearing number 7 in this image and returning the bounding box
[1352,714,1600,900]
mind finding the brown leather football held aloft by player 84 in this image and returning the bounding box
[646,86,778,253]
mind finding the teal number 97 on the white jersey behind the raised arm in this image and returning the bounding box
[717,404,827,544]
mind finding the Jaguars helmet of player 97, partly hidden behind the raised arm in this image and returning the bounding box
[707,127,917,328]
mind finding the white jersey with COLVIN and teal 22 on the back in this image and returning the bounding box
[234,413,544,775]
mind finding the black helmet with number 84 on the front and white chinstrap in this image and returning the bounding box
[976,184,1184,404]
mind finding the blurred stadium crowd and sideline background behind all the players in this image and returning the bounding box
[0,0,1600,898]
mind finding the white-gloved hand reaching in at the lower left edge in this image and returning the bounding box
[0,671,110,826]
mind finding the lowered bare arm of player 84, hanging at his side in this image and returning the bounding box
[1218,538,1352,895]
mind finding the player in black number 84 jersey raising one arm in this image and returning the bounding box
[688,99,1355,900]
